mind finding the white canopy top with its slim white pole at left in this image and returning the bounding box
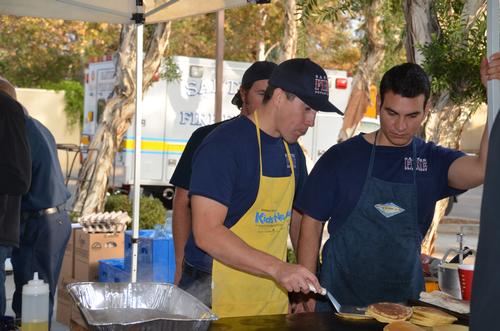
[0,0,256,282]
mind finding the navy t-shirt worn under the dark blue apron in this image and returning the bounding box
[294,134,464,236]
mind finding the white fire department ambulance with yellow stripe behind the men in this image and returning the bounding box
[82,56,376,206]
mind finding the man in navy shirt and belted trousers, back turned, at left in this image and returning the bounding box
[4,84,71,326]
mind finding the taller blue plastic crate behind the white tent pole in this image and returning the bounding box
[125,230,175,283]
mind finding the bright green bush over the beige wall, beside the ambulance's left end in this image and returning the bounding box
[41,80,84,128]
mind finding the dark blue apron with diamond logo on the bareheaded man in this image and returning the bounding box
[316,133,424,311]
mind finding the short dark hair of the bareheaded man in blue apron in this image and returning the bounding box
[379,63,431,106]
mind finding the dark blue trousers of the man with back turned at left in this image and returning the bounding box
[11,212,71,321]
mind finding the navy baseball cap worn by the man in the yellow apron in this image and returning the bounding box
[269,59,344,115]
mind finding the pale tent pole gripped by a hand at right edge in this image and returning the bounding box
[488,0,500,133]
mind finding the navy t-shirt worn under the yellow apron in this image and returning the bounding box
[184,116,307,272]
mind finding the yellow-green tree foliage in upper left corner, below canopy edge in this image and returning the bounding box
[0,15,119,88]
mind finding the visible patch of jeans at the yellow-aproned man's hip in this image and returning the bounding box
[179,261,212,308]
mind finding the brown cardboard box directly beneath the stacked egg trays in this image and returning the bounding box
[74,229,124,282]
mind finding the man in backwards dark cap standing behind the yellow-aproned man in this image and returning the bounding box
[170,61,278,287]
